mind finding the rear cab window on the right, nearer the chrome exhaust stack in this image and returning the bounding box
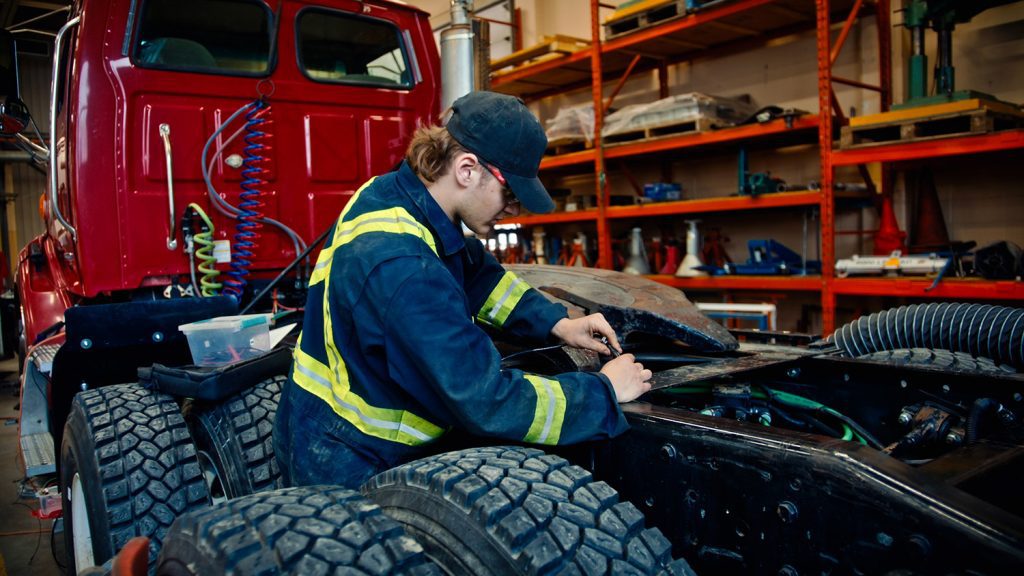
[297,8,413,88]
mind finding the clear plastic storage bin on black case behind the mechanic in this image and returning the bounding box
[178,314,271,366]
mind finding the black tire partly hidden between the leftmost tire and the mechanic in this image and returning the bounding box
[188,376,287,498]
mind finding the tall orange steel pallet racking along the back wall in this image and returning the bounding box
[492,0,1024,333]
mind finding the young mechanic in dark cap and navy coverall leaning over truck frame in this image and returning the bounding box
[274,92,651,489]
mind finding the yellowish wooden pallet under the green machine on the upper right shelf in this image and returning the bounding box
[840,99,1024,149]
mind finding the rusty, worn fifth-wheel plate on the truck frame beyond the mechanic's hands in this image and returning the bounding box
[506,264,739,353]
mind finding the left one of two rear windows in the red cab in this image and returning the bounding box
[132,0,272,76]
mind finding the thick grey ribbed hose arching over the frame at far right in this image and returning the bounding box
[828,302,1024,368]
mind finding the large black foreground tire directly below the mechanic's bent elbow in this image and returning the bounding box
[362,447,692,576]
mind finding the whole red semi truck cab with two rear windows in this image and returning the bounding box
[17,0,440,345]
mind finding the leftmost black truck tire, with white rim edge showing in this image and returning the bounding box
[60,384,209,574]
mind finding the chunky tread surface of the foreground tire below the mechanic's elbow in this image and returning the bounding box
[362,447,685,575]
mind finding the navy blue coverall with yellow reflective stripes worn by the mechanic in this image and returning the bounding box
[274,163,627,488]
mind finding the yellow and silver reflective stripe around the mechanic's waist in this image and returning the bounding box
[292,334,444,446]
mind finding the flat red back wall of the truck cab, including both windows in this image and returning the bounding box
[92,0,438,289]
